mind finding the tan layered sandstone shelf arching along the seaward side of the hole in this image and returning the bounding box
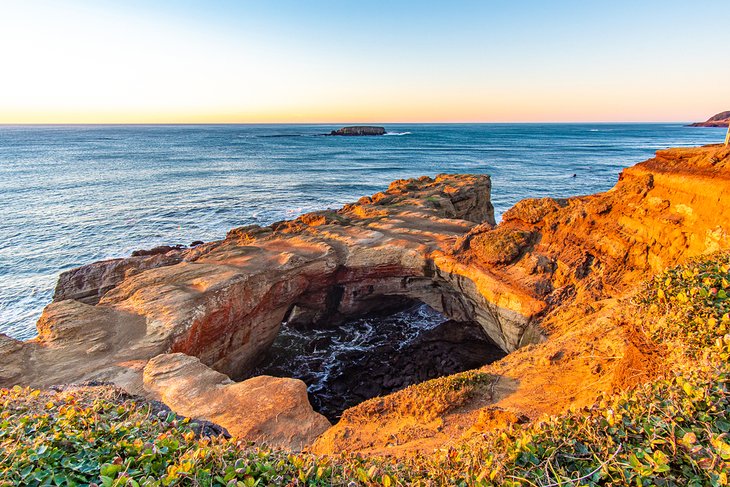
[0,175,512,450]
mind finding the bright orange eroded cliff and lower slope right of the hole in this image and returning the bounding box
[314,146,730,454]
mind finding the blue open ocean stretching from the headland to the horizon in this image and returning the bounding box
[0,124,724,338]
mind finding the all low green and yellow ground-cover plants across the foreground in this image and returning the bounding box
[0,253,730,487]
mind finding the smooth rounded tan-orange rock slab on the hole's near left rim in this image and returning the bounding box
[144,353,331,450]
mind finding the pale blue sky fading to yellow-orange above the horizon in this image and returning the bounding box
[0,0,730,124]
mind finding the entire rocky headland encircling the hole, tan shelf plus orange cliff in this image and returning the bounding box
[0,146,730,454]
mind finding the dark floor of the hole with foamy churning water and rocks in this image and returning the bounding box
[249,300,506,422]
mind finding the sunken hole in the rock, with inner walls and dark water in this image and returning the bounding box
[162,259,534,422]
